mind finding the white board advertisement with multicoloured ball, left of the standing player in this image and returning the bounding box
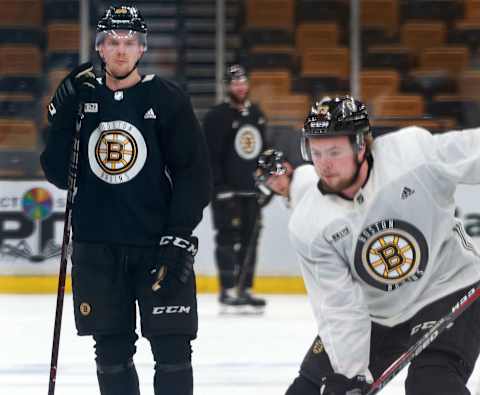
[0,181,67,275]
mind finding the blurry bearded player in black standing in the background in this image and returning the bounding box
[204,65,266,312]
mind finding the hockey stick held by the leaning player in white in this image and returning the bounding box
[365,283,480,395]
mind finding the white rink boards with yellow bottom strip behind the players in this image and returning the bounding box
[0,181,480,293]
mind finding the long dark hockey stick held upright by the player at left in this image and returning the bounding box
[48,103,84,395]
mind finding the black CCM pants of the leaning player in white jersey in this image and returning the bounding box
[286,290,480,395]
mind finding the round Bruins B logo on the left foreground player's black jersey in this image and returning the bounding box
[88,121,147,184]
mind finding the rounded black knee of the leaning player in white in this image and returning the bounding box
[405,349,471,395]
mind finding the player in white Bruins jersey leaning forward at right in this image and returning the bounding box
[287,96,480,395]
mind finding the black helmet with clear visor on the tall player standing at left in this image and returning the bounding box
[95,5,148,50]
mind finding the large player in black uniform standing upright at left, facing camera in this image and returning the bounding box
[41,6,211,395]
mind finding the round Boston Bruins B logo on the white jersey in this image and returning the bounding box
[355,219,428,291]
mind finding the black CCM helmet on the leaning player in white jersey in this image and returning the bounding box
[301,96,370,161]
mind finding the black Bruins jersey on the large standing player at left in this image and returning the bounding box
[41,75,211,245]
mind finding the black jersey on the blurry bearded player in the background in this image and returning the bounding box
[204,102,266,193]
